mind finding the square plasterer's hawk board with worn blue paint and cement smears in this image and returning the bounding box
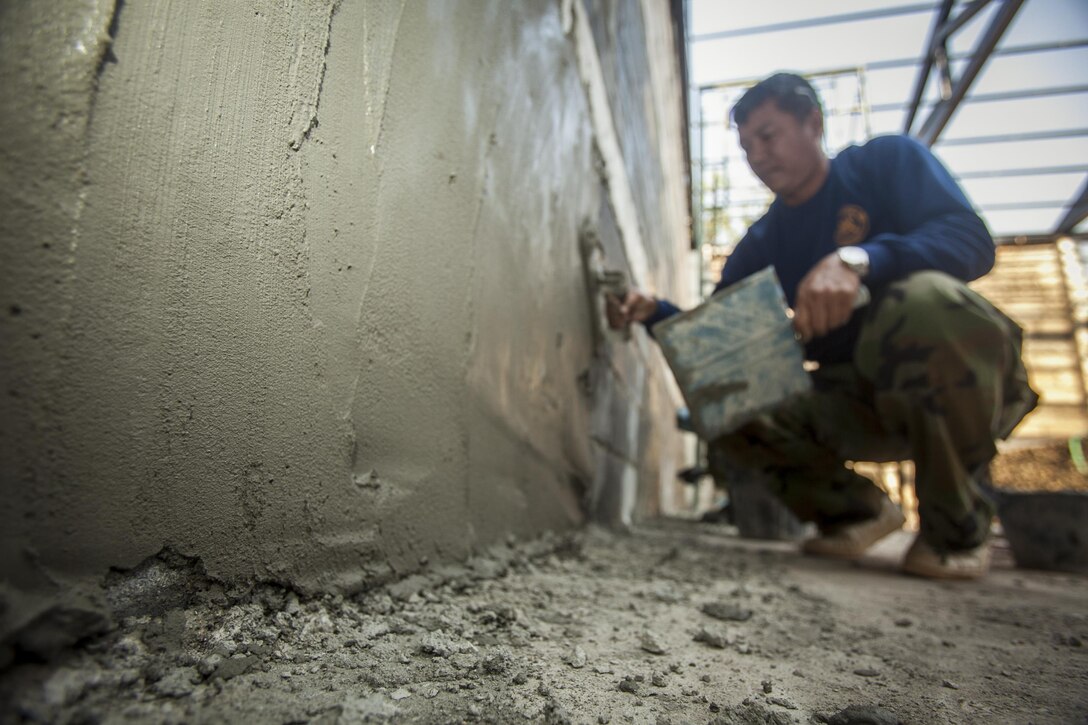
[654,267,813,441]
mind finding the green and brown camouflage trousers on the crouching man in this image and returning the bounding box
[709,271,1038,551]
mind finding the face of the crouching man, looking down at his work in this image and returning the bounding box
[738,99,827,205]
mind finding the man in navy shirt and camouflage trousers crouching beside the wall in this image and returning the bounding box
[608,73,1038,578]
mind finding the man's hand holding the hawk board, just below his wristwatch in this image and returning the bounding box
[793,251,862,342]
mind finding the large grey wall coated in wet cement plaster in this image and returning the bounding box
[0,0,690,631]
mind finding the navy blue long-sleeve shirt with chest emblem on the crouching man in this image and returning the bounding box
[646,136,994,364]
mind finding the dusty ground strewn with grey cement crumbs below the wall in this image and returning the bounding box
[0,520,1088,725]
